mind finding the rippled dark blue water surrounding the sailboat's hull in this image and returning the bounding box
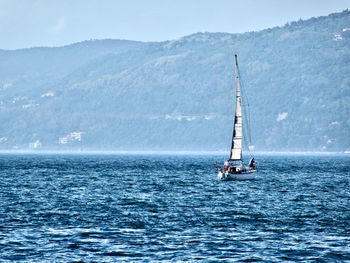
[0,154,350,262]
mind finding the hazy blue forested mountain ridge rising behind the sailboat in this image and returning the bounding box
[0,10,350,151]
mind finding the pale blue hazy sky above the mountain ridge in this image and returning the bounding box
[0,0,350,49]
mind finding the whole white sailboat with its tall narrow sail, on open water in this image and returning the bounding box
[215,55,257,181]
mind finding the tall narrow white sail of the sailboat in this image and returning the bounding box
[230,55,242,161]
